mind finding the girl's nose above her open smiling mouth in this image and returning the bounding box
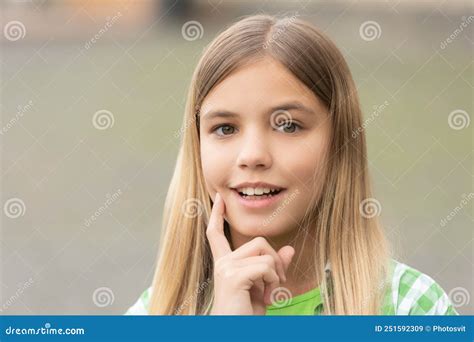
[237,132,273,169]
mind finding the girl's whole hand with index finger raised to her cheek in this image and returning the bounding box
[206,193,295,315]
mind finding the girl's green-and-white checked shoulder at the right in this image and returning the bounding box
[386,259,457,315]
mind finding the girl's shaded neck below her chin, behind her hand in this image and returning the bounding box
[229,222,319,297]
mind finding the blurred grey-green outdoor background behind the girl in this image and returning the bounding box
[0,0,474,315]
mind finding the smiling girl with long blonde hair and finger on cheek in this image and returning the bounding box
[127,15,456,315]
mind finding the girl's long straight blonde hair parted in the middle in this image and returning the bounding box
[149,15,390,315]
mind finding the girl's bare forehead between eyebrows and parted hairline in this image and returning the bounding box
[201,57,324,113]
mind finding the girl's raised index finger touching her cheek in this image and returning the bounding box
[206,193,232,260]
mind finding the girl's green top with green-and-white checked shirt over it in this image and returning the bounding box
[125,260,458,315]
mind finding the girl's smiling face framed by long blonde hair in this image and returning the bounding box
[200,57,331,243]
